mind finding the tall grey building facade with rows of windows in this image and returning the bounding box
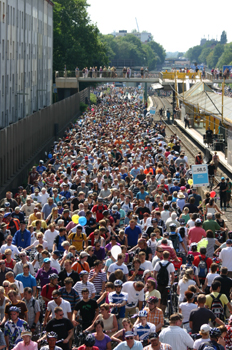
[0,0,53,128]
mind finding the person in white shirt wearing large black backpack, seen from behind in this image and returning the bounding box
[154,251,175,313]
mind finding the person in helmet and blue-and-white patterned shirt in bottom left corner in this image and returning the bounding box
[4,306,30,350]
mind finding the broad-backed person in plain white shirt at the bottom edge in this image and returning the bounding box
[159,314,194,350]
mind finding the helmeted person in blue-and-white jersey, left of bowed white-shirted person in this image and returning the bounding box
[108,280,128,329]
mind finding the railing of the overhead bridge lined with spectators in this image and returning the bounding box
[55,69,160,79]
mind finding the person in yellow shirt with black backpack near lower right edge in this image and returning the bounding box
[205,281,232,322]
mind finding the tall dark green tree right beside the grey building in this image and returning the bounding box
[53,0,109,70]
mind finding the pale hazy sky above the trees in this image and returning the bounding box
[87,0,232,52]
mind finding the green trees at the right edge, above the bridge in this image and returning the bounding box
[185,31,232,69]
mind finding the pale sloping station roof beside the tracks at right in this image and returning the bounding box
[179,82,232,125]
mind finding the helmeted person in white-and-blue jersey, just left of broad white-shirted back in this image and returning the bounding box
[134,310,156,341]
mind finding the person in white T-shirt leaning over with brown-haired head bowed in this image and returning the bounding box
[122,281,144,317]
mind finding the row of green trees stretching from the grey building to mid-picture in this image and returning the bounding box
[53,0,165,71]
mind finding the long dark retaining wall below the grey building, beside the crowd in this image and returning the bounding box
[0,88,90,198]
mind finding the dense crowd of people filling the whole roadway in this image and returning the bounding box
[0,86,232,350]
